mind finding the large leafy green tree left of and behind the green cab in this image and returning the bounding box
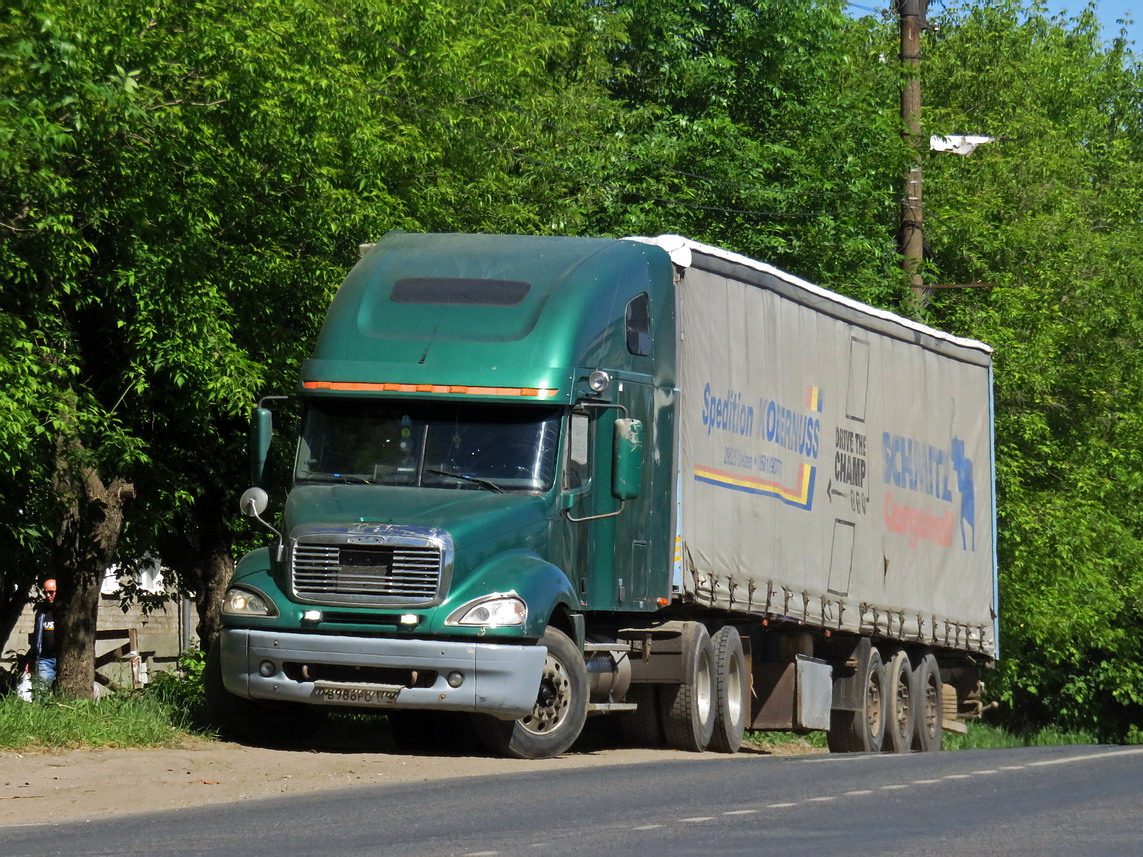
[0,0,626,695]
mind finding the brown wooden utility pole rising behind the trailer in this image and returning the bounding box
[897,0,927,309]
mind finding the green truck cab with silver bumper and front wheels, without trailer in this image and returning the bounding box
[210,233,674,756]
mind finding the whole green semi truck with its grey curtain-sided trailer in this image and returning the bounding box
[207,232,997,759]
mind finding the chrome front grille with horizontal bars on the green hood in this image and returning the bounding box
[290,528,451,607]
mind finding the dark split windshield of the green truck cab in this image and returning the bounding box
[294,399,560,491]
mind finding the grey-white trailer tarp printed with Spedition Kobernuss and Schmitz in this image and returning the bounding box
[657,239,996,655]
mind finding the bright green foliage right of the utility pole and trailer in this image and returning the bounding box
[925,0,1143,736]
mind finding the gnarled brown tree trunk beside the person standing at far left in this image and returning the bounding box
[53,439,134,699]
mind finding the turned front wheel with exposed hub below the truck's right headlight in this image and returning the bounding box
[472,627,588,759]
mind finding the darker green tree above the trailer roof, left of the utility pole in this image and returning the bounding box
[597,0,906,304]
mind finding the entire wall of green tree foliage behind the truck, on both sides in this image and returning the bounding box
[0,0,1143,736]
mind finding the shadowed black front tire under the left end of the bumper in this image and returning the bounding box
[202,640,326,747]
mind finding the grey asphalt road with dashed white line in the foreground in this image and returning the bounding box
[0,746,1143,857]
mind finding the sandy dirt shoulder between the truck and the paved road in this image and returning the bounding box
[0,740,813,827]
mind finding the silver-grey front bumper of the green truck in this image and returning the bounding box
[219,628,547,720]
